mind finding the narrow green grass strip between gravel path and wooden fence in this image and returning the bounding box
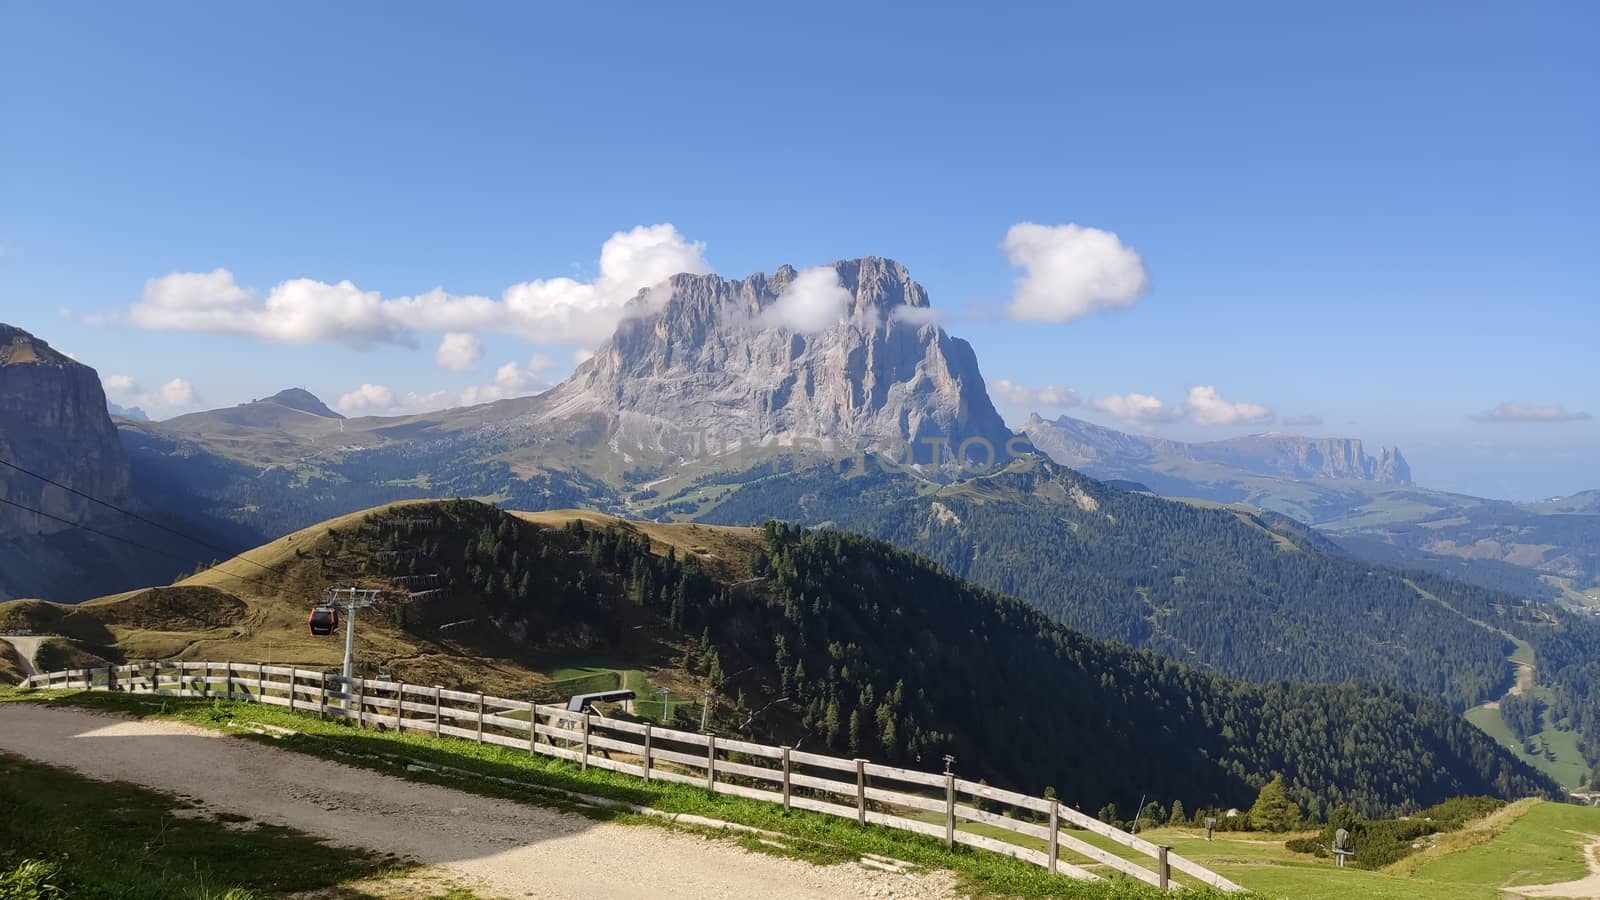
[0,689,1221,900]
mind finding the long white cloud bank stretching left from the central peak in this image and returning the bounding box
[109,224,710,348]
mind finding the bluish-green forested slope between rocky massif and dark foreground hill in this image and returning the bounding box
[702,461,1520,709]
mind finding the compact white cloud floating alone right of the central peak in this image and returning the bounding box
[1000,223,1150,322]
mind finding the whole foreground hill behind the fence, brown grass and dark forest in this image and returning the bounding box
[0,501,1555,814]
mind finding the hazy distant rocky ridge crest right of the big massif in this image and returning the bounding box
[1021,413,1413,485]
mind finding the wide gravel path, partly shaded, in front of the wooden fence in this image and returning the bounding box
[0,703,955,900]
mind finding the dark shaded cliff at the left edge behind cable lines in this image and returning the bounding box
[0,323,130,540]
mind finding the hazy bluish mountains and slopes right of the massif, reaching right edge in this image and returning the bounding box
[1021,415,1600,604]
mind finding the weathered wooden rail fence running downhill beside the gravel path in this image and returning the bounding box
[22,661,1243,892]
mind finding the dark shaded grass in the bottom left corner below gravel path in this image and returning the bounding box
[0,754,397,900]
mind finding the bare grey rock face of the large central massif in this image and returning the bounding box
[538,258,1011,463]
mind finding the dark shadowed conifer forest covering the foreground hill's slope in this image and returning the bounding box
[384,503,1555,815]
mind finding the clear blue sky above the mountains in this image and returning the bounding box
[0,0,1600,498]
